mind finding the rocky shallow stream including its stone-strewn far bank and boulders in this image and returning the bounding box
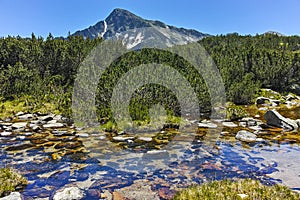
[0,91,300,199]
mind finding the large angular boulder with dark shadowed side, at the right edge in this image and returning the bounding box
[264,110,299,131]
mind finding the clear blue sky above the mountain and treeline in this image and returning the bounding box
[0,0,300,37]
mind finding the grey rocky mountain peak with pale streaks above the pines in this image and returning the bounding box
[74,8,209,49]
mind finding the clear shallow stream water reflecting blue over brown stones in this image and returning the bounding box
[0,105,300,199]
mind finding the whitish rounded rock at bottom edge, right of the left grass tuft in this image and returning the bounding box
[53,187,84,200]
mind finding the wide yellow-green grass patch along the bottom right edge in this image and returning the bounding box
[174,179,300,200]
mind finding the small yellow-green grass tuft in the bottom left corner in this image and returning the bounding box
[0,167,27,197]
